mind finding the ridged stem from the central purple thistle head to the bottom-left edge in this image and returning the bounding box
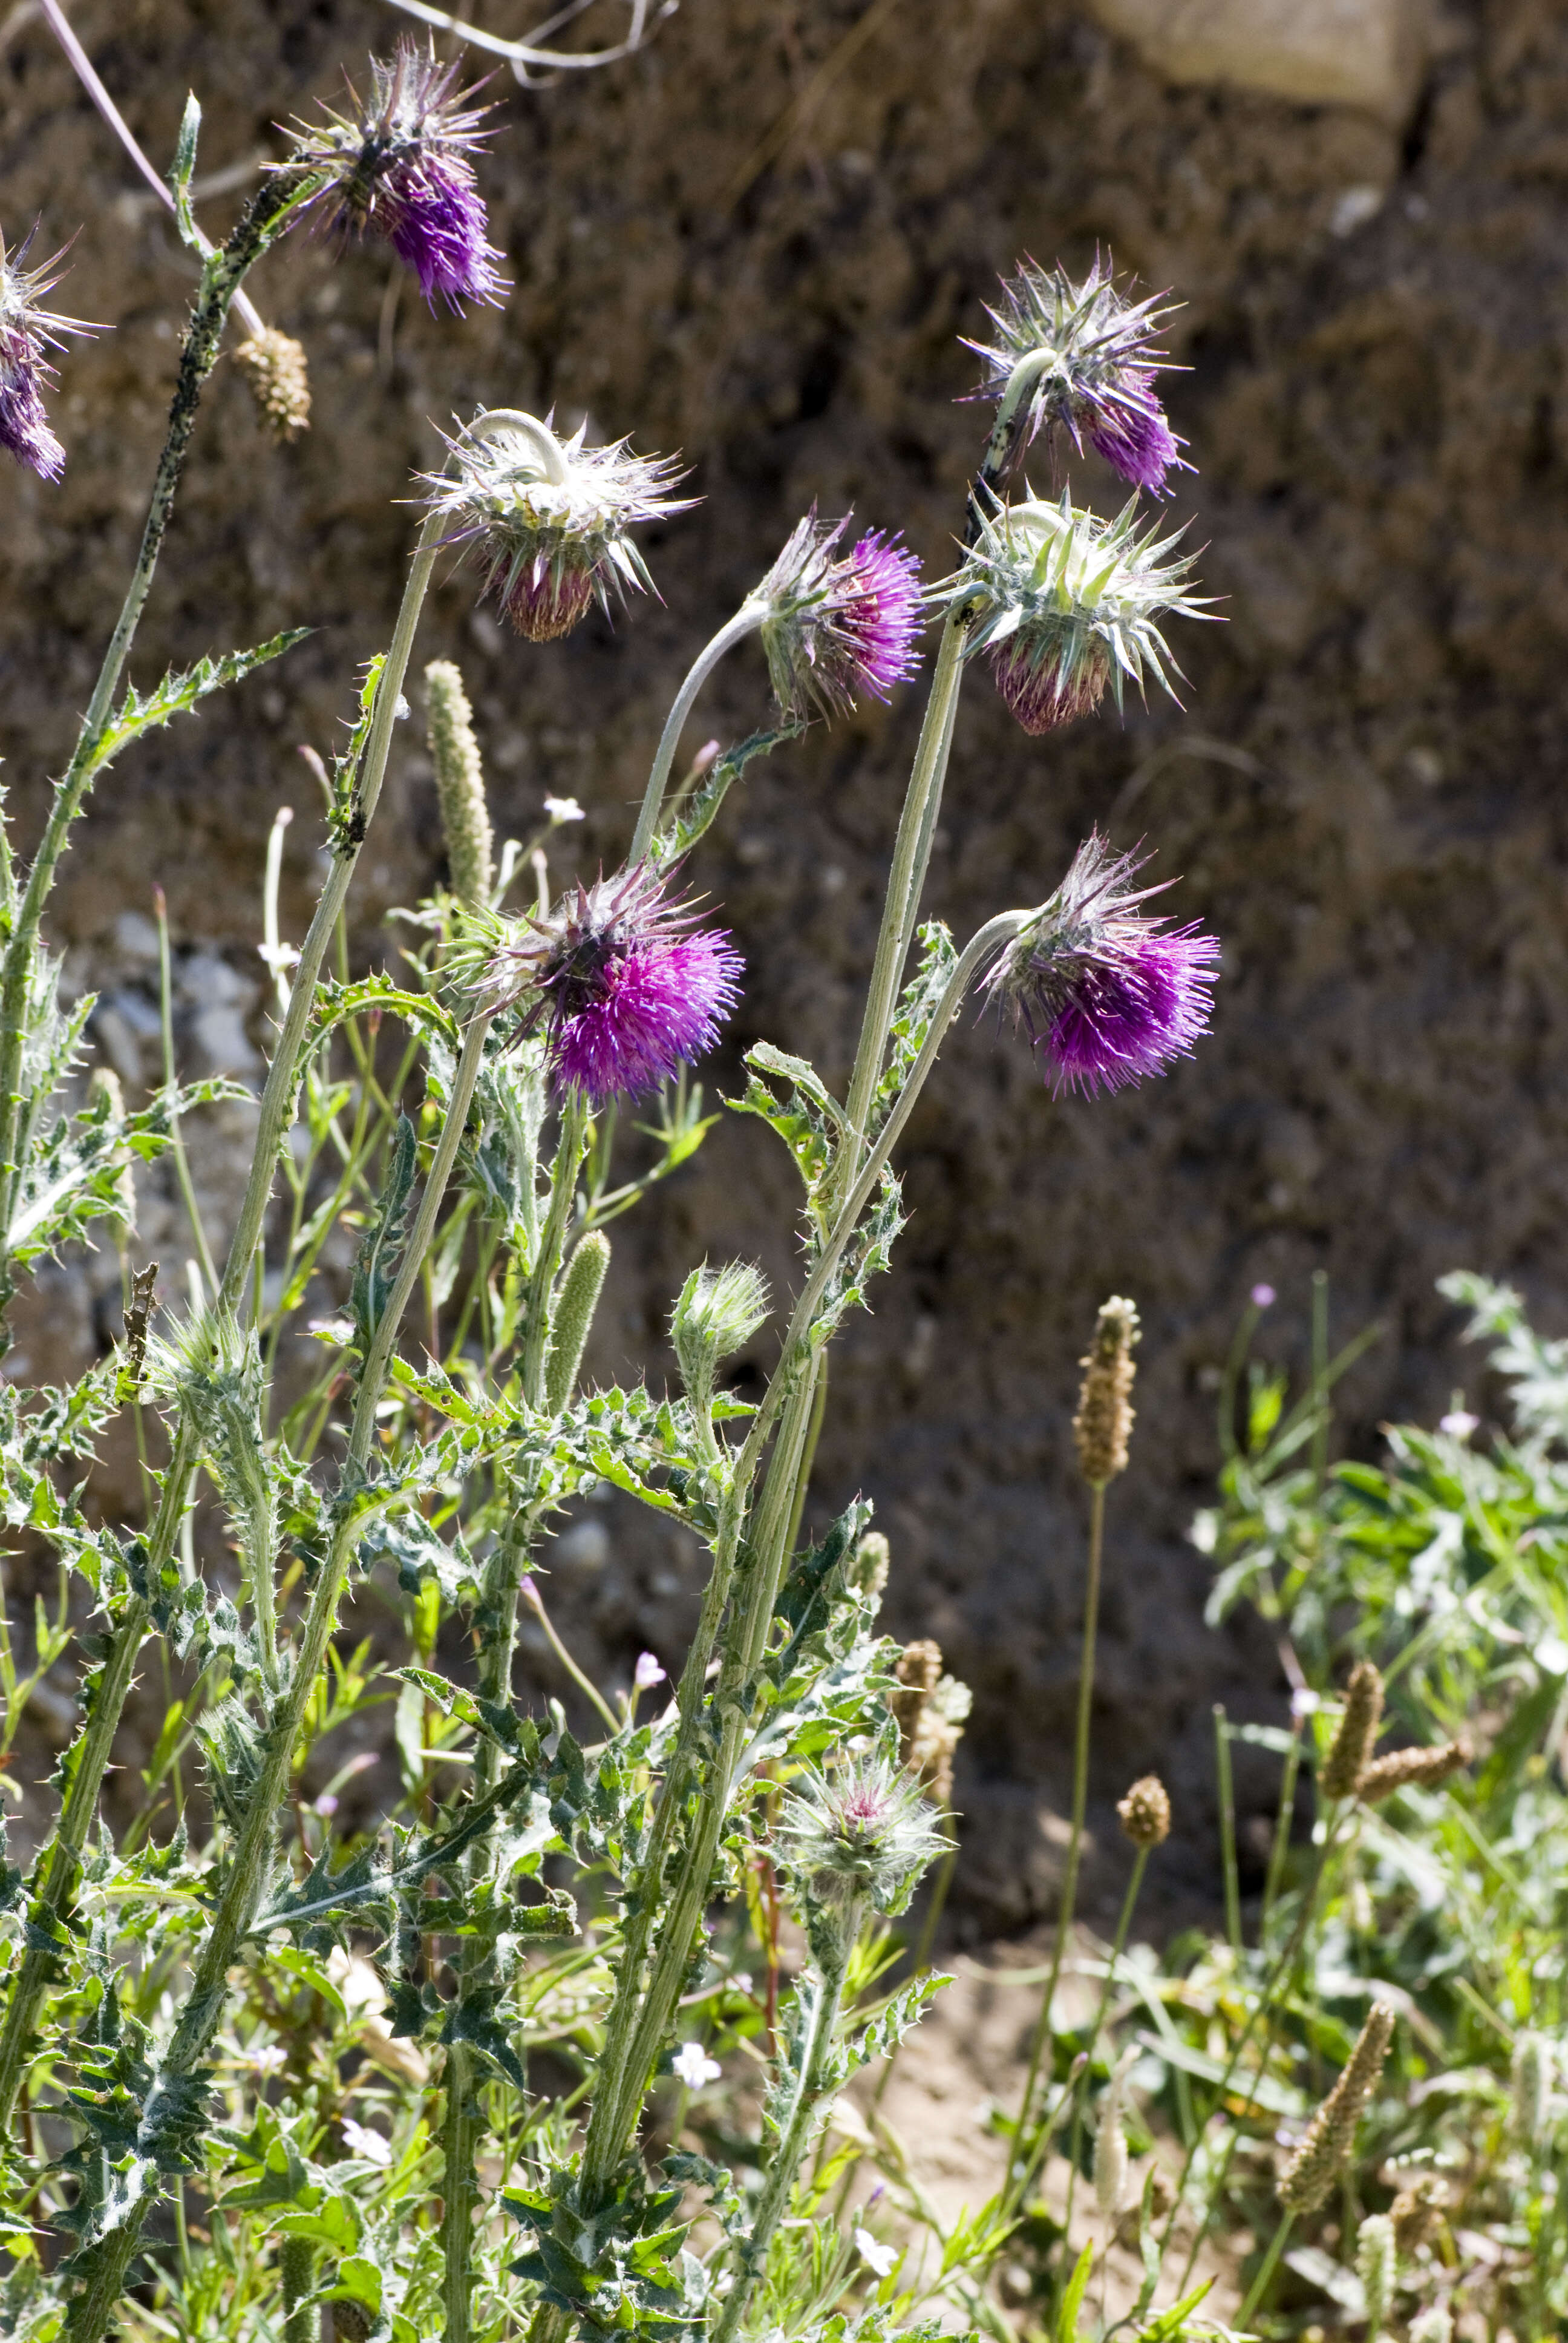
[68,1012,490,2343]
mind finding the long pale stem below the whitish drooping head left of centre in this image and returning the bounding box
[0,471,464,2130]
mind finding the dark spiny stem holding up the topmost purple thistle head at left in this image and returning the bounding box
[0,174,316,1237]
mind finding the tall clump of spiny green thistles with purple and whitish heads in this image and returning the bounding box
[0,42,1237,2343]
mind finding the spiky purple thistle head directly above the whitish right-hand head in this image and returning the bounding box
[968,258,1186,497]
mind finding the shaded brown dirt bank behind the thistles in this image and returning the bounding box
[0,0,1568,1928]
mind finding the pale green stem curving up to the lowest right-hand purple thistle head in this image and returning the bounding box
[574,911,1034,2193]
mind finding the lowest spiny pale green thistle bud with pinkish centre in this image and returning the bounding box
[778,1757,949,1912]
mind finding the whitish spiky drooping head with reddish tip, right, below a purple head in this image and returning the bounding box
[940,494,1209,736]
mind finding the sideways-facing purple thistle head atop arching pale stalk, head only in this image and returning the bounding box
[750,506,921,717]
